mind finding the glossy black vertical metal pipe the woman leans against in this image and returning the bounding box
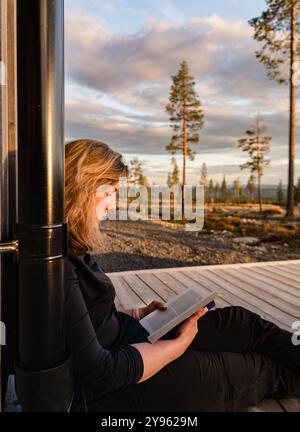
[17,0,71,411]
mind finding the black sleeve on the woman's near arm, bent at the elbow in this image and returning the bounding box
[64,259,144,395]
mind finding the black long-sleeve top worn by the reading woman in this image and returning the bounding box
[64,250,144,398]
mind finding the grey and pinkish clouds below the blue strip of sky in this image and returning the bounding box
[66,10,299,182]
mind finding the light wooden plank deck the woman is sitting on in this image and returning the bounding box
[107,260,300,412]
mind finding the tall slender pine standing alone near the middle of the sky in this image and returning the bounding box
[166,61,204,210]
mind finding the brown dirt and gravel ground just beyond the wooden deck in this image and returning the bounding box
[95,220,300,272]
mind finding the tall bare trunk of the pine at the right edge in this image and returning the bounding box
[286,1,297,217]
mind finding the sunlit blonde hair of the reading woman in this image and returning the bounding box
[65,139,128,255]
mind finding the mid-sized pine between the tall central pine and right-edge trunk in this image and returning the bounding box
[238,115,272,212]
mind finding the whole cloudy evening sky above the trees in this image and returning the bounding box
[65,0,300,185]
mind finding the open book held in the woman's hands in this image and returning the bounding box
[140,287,218,343]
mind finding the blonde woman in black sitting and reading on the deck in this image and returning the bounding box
[65,140,300,412]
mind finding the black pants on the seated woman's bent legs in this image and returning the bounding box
[89,307,300,412]
